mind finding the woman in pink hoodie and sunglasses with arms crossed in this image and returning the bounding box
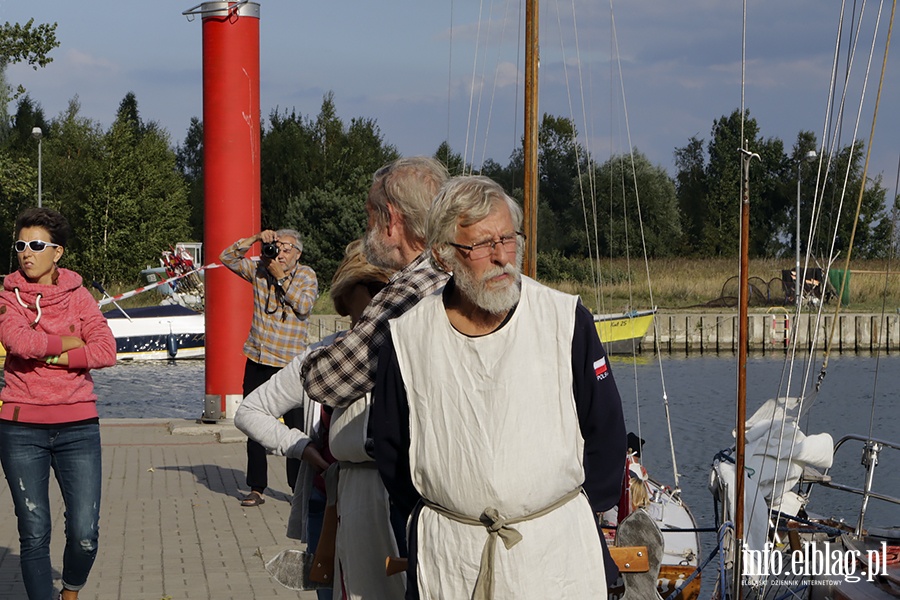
[0,208,116,600]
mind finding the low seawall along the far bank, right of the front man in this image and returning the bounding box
[642,311,900,354]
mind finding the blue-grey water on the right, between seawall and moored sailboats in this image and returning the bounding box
[614,355,900,525]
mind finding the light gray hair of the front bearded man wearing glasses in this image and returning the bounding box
[426,175,523,269]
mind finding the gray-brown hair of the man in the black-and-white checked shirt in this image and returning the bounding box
[368,156,449,247]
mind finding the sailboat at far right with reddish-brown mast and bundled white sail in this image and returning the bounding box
[710,5,900,600]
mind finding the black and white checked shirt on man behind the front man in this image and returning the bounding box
[301,253,447,406]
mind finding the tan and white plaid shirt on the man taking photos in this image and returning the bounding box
[219,243,319,367]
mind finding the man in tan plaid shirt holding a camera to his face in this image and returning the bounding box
[219,229,319,506]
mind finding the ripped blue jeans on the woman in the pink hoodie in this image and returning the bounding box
[0,421,102,600]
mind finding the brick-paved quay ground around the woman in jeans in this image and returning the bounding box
[0,419,316,600]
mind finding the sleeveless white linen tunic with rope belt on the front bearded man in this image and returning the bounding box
[391,277,606,600]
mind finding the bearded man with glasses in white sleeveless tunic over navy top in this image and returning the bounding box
[371,177,626,600]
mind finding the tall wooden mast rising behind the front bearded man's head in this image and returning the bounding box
[522,0,540,279]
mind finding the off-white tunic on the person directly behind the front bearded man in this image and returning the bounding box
[328,394,406,600]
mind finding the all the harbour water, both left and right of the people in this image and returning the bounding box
[81,354,900,525]
